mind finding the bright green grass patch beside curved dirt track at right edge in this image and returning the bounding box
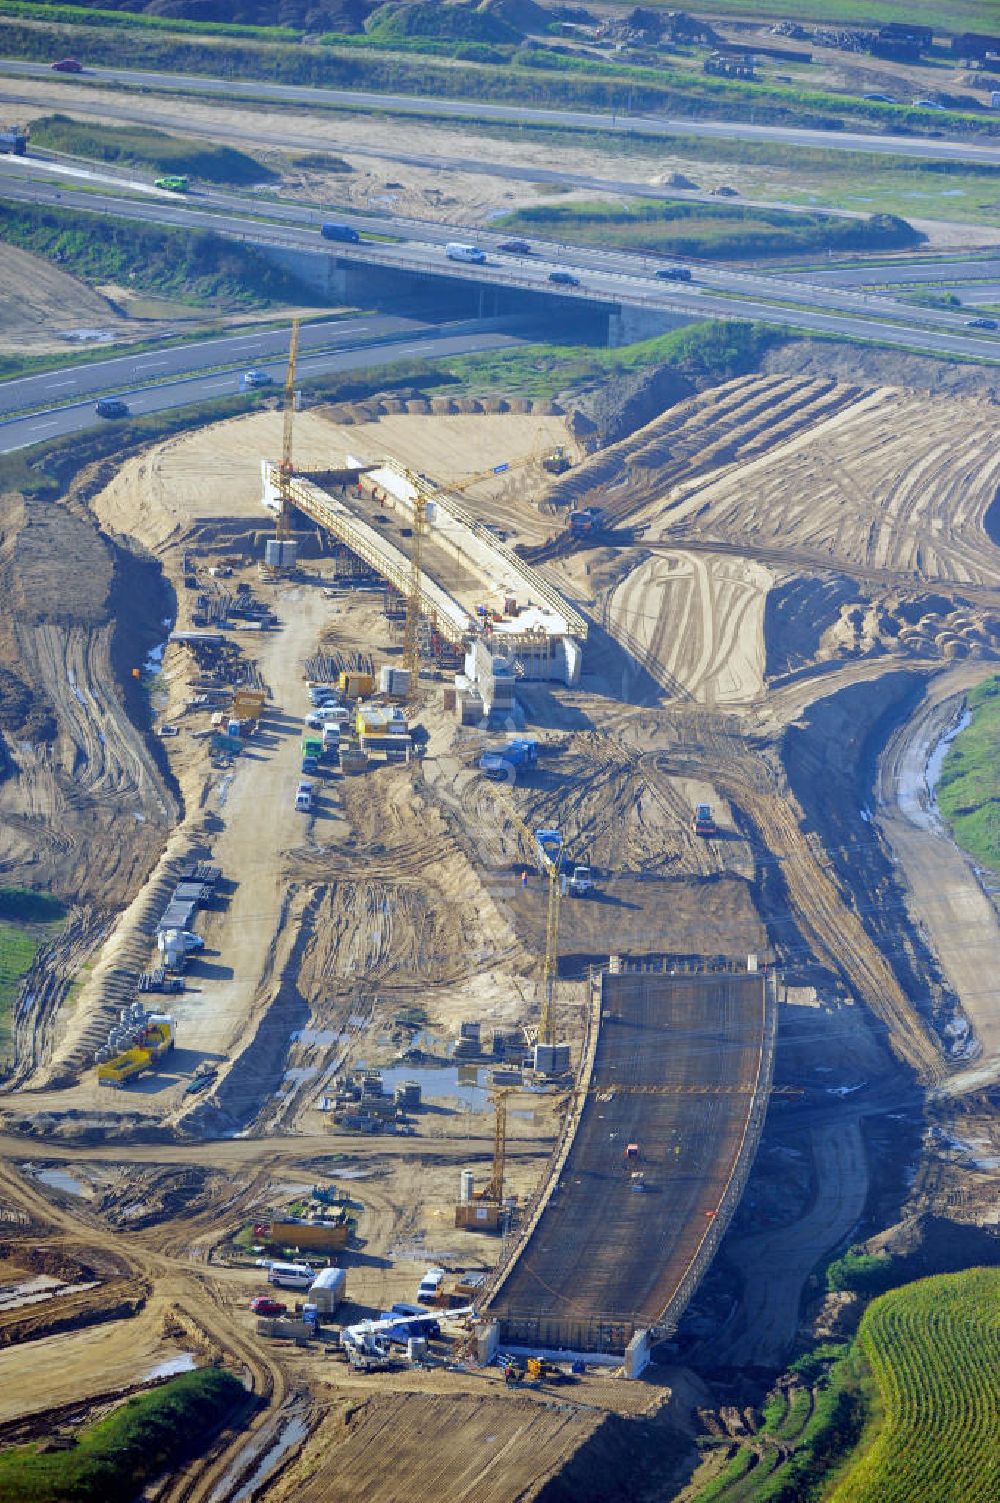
[937,675,1000,872]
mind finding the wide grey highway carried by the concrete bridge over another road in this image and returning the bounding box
[0,158,1000,361]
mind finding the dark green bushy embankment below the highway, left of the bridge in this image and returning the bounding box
[0,203,317,308]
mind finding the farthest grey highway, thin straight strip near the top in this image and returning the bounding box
[0,59,1000,167]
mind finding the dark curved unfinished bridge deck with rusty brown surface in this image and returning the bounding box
[489,972,774,1351]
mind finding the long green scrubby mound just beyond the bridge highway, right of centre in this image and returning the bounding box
[493,198,923,260]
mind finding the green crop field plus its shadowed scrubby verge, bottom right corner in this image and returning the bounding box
[682,1258,1000,1503]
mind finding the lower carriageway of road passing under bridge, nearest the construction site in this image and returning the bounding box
[0,325,519,454]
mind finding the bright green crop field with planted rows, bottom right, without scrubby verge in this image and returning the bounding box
[830,1269,1000,1503]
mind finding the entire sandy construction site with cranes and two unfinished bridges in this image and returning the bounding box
[0,314,1000,1503]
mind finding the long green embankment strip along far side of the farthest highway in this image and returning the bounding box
[0,0,1000,135]
